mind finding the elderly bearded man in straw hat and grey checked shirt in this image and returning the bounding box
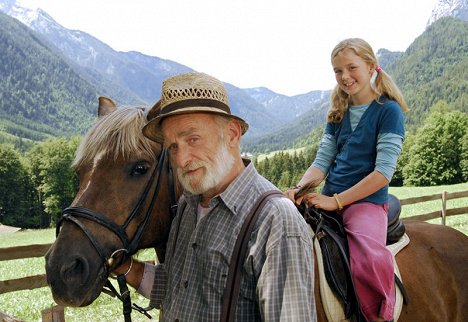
[118,73,316,322]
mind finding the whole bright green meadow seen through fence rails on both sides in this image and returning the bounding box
[0,183,468,322]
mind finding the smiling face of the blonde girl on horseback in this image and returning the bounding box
[332,48,376,105]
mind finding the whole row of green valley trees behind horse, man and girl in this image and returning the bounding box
[0,101,468,228]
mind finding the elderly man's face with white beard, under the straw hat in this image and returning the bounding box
[162,113,234,194]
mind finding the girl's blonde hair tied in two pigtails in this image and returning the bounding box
[327,38,408,123]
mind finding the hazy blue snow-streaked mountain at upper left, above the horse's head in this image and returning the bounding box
[0,0,192,104]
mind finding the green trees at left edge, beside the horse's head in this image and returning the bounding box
[0,137,80,228]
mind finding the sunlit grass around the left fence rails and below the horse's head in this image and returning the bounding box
[0,229,158,322]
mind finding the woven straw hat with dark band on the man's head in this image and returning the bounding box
[143,73,249,143]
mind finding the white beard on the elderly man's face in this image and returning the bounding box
[177,142,234,195]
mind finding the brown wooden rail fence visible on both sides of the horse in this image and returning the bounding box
[0,190,468,322]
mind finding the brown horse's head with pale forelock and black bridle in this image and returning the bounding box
[46,97,180,306]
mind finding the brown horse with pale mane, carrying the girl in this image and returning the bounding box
[46,99,468,322]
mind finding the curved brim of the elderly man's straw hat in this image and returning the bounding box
[142,103,249,143]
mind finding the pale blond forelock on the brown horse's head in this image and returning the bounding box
[72,107,156,168]
